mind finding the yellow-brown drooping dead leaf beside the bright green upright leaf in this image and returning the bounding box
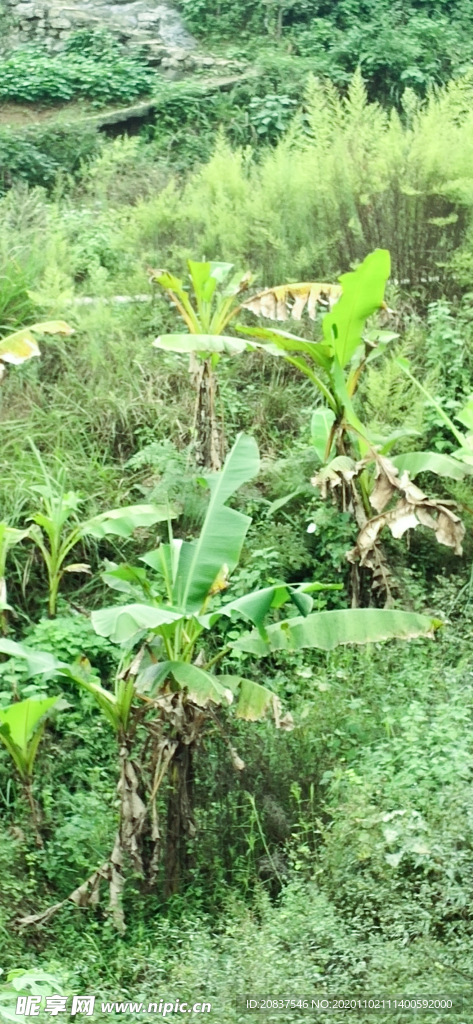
[242,282,342,321]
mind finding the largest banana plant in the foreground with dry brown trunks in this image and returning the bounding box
[54,434,438,928]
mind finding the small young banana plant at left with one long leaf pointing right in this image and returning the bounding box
[29,443,174,617]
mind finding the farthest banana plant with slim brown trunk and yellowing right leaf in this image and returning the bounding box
[151,260,341,470]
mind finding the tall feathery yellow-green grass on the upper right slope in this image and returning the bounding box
[128,74,473,292]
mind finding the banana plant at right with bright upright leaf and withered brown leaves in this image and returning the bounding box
[235,249,473,604]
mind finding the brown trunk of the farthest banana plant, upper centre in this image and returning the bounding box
[189,352,225,472]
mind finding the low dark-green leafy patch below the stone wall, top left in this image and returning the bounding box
[0,38,155,105]
